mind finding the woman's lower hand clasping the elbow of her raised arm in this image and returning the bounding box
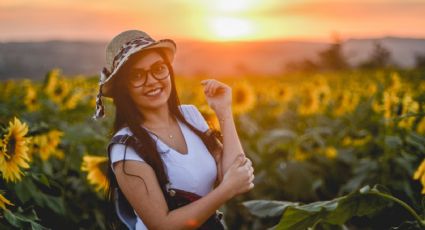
[220,154,254,198]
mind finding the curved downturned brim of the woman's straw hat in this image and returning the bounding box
[99,39,176,97]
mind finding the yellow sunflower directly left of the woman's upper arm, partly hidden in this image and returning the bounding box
[81,155,108,191]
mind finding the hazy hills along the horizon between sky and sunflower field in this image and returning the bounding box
[0,37,425,80]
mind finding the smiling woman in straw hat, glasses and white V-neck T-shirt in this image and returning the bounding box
[96,30,254,229]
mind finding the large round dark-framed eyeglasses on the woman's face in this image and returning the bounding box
[128,62,170,87]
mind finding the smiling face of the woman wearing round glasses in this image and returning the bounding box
[126,50,171,110]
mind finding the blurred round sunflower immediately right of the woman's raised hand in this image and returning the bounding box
[232,81,256,114]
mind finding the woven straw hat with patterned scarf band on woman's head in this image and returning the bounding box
[93,30,176,119]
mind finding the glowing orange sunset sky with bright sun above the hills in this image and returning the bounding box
[0,0,425,42]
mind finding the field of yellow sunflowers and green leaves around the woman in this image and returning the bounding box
[0,69,425,229]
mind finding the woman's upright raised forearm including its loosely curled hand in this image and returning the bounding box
[201,79,245,175]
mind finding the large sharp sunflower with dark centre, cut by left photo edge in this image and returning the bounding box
[0,117,30,182]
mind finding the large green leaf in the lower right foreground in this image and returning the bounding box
[243,186,425,230]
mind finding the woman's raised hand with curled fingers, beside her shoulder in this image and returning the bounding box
[201,79,232,114]
